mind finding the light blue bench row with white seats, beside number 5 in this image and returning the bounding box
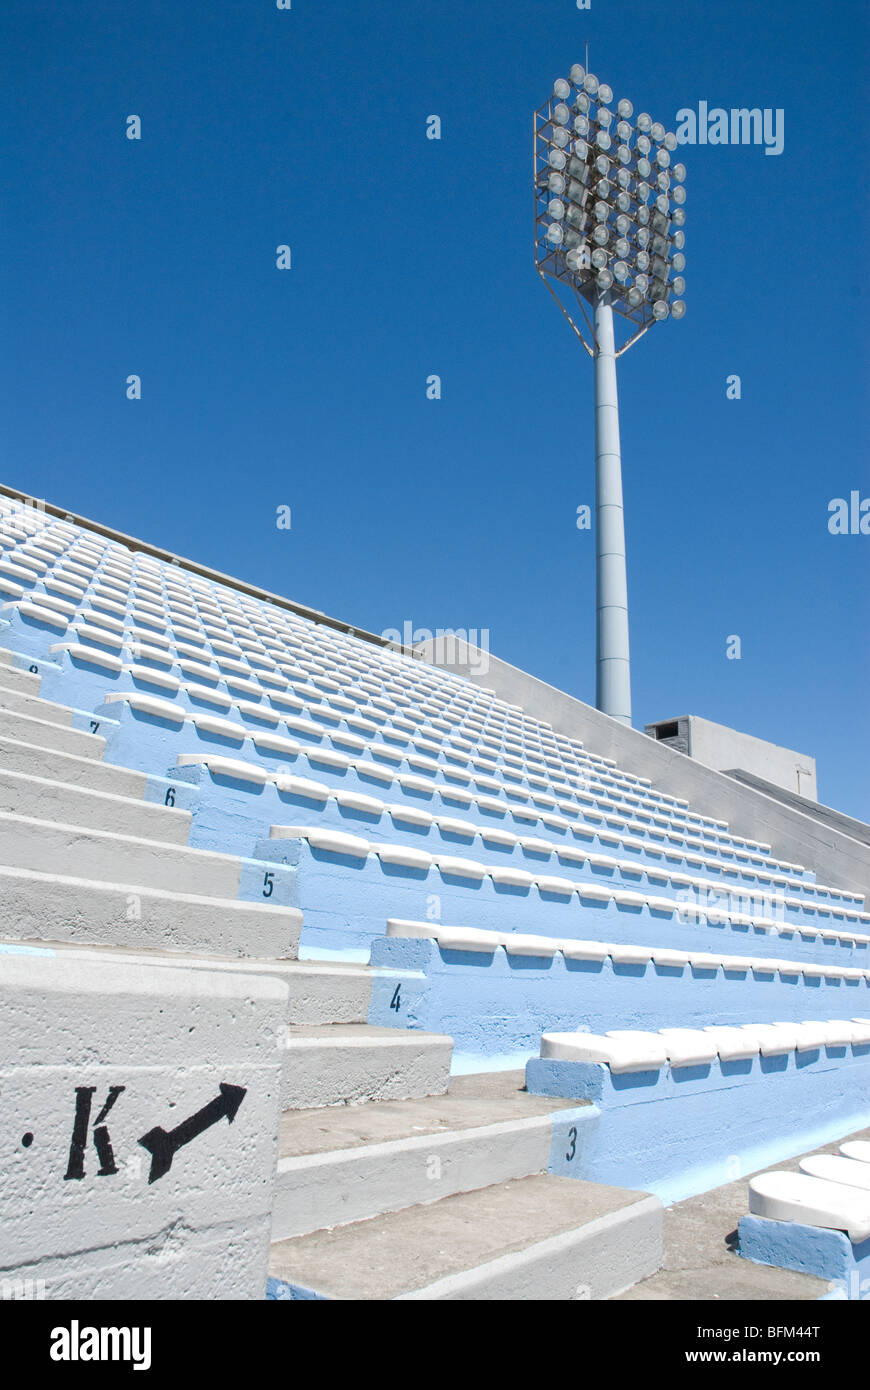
[247,817,869,961]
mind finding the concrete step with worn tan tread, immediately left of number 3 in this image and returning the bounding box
[272,1072,577,1240]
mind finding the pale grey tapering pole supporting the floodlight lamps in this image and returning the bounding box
[595,292,631,724]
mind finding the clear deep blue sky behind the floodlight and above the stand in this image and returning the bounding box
[0,0,870,819]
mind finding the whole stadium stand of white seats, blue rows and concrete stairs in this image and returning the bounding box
[0,496,870,1301]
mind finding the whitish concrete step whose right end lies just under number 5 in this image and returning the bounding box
[0,867,301,961]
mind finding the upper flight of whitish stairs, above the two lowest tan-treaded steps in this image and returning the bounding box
[0,652,452,1106]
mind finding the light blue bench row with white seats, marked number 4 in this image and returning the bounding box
[366,919,870,1070]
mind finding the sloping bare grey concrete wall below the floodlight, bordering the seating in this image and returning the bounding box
[417,642,870,897]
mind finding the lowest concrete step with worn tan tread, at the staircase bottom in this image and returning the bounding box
[270,1176,662,1301]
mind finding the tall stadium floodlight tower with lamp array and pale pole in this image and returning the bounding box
[535,63,685,724]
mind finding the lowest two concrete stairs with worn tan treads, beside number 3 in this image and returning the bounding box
[271,1072,662,1301]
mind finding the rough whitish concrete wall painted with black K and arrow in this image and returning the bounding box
[0,945,286,1300]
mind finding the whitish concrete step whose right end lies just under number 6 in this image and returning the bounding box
[0,759,190,845]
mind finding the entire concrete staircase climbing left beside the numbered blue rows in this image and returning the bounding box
[0,652,662,1300]
